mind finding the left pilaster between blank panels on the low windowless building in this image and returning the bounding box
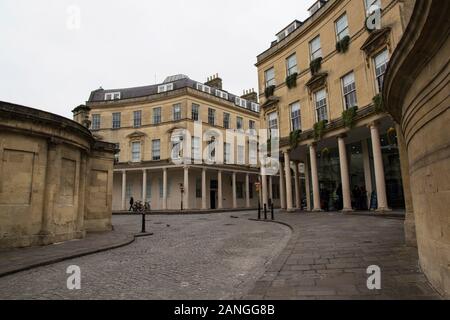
[40,139,61,241]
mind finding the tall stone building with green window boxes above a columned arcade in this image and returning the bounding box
[256,0,409,218]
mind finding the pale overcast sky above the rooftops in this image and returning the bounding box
[0,0,314,118]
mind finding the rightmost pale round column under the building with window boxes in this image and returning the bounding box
[370,123,390,212]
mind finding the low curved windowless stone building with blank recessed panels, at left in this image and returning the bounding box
[0,102,114,247]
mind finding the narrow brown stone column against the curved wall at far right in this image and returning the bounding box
[395,124,417,247]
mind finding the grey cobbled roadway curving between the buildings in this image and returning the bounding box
[0,212,292,299]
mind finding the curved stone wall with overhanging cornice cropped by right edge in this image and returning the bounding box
[383,0,450,298]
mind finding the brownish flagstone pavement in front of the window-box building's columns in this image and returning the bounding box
[244,213,440,300]
